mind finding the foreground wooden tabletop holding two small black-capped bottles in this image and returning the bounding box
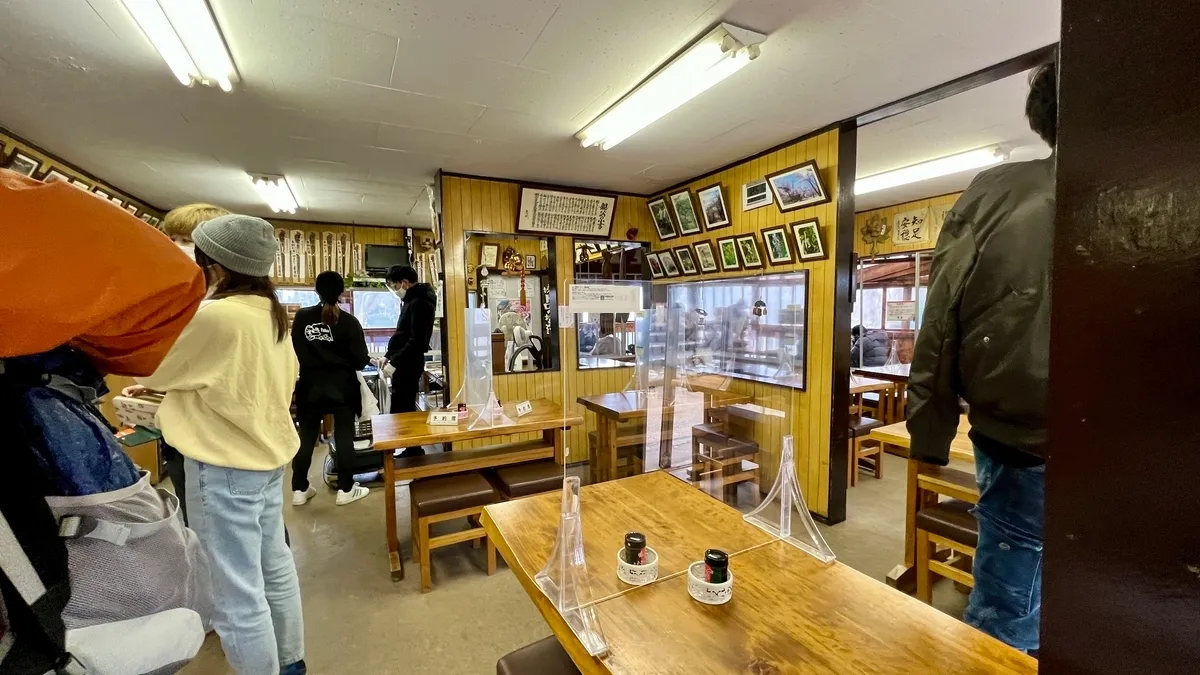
[481,472,1037,675]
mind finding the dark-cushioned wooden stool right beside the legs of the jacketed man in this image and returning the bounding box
[917,500,979,603]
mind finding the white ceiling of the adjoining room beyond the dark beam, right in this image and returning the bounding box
[854,72,1050,211]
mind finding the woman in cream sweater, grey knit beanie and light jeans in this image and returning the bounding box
[138,215,306,675]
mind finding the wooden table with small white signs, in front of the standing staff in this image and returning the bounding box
[371,399,583,581]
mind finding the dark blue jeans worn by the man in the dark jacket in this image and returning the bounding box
[962,448,1045,652]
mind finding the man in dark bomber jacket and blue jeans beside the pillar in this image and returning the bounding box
[907,65,1058,652]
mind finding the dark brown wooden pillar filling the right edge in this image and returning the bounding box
[1040,0,1200,675]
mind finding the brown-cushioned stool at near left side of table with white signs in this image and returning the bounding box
[409,471,498,593]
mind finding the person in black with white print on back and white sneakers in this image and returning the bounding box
[292,271,371,506]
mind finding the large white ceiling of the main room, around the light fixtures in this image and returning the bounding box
[0,0,1058,227]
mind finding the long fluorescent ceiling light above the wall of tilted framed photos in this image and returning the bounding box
[575,24,767,150]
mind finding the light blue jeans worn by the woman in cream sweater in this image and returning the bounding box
[185,459,304,675]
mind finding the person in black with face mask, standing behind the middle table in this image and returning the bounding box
[385,265,438,456]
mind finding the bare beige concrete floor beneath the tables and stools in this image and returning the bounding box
[175,444,966,675]
